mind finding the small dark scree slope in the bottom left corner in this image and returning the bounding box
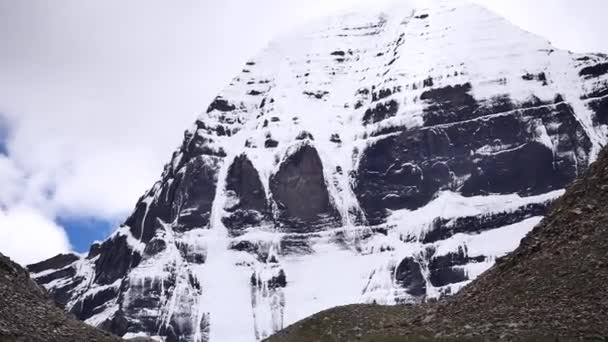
[0,254,121,342]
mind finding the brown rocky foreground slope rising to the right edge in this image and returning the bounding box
[267,150,608,342]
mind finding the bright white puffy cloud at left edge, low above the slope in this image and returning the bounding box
[0,206,71,265]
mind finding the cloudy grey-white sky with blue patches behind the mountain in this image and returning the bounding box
[0,0,608,263]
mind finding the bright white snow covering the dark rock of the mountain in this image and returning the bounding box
[29,0,607,341]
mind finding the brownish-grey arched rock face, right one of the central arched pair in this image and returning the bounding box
[270,145,340,231]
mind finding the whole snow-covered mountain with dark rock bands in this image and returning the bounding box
[29,0,608,342]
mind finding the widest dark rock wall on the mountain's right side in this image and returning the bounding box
[355,97,591,224]
